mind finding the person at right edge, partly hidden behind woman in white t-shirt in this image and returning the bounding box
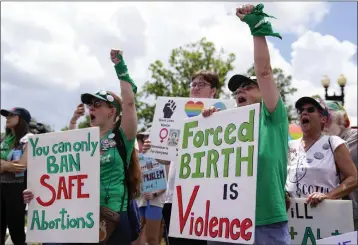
[323,101,358,231]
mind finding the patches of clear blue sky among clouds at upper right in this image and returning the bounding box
[270,2,358,64]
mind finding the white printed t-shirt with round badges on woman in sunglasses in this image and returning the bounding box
[286,136,346,197]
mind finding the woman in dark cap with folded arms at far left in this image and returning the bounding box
[1,107,31,245]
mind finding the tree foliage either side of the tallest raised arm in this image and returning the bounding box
[246,66,297,123]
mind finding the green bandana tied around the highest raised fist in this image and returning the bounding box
[243,3,282,39]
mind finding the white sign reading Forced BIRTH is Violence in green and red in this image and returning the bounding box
[169,104,260,244]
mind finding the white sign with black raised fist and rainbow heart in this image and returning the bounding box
[147,97,235,161]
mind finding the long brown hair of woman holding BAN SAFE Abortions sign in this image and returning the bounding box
[107,91,142,199]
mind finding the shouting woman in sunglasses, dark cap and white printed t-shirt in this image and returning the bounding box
[286,97,357,207]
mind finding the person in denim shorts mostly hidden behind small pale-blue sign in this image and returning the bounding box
[137,129,165,245]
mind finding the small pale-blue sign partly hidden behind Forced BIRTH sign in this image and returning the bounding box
[138,153,167,193]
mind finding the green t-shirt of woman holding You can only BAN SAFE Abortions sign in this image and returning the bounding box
[100,128,135,212]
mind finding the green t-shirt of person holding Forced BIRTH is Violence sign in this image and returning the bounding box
[256,98,288,226]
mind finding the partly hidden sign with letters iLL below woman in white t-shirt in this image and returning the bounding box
[287,198,354,245]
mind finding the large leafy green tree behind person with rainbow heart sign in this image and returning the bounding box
[136,38,235,128]
